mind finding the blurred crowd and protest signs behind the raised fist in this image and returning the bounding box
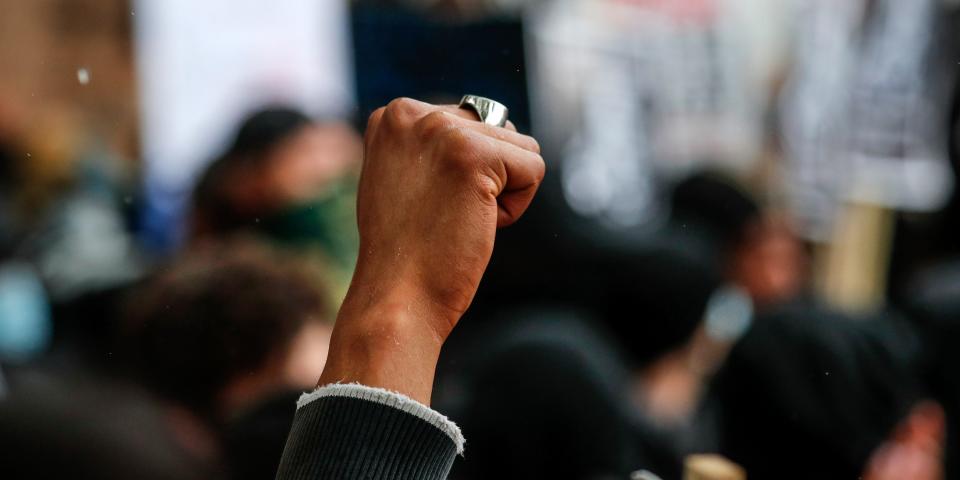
[0,0,960,479]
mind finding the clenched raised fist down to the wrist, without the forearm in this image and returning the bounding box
[344,99,544,341]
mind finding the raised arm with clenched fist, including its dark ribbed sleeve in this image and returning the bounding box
[278,99,544,479]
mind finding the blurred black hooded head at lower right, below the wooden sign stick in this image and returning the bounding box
[700,306,922,480]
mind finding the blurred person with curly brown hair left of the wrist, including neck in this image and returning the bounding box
[121,242,332,478]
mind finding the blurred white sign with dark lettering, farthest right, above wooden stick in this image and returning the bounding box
[781,0,952,240]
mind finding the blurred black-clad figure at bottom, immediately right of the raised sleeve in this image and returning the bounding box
[435,303,680,479]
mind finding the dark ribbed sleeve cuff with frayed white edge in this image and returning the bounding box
[277,384,464,480]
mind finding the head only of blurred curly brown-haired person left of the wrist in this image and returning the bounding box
[124,244,330,421]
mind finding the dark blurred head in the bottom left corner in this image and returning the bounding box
[0,379,211,480]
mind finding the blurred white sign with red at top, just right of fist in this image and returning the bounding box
[528,0,764,230]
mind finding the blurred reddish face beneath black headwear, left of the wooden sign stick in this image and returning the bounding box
[731,220,808,305]
